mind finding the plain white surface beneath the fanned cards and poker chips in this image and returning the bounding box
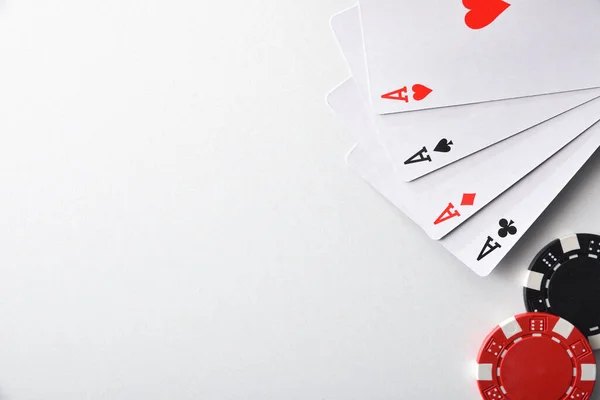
[0,0,600,400]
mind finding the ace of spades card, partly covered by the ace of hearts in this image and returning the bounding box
[331,7,600,181]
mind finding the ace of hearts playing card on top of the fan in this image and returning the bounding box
[360,0,600,114]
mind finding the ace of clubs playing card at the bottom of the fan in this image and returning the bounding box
[335,82,600,276]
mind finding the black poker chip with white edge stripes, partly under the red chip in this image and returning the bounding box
[523,234,600,350]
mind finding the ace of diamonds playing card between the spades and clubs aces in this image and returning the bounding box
[329,80,600,239]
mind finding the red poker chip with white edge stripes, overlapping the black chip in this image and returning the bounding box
[477,313,596,400]
